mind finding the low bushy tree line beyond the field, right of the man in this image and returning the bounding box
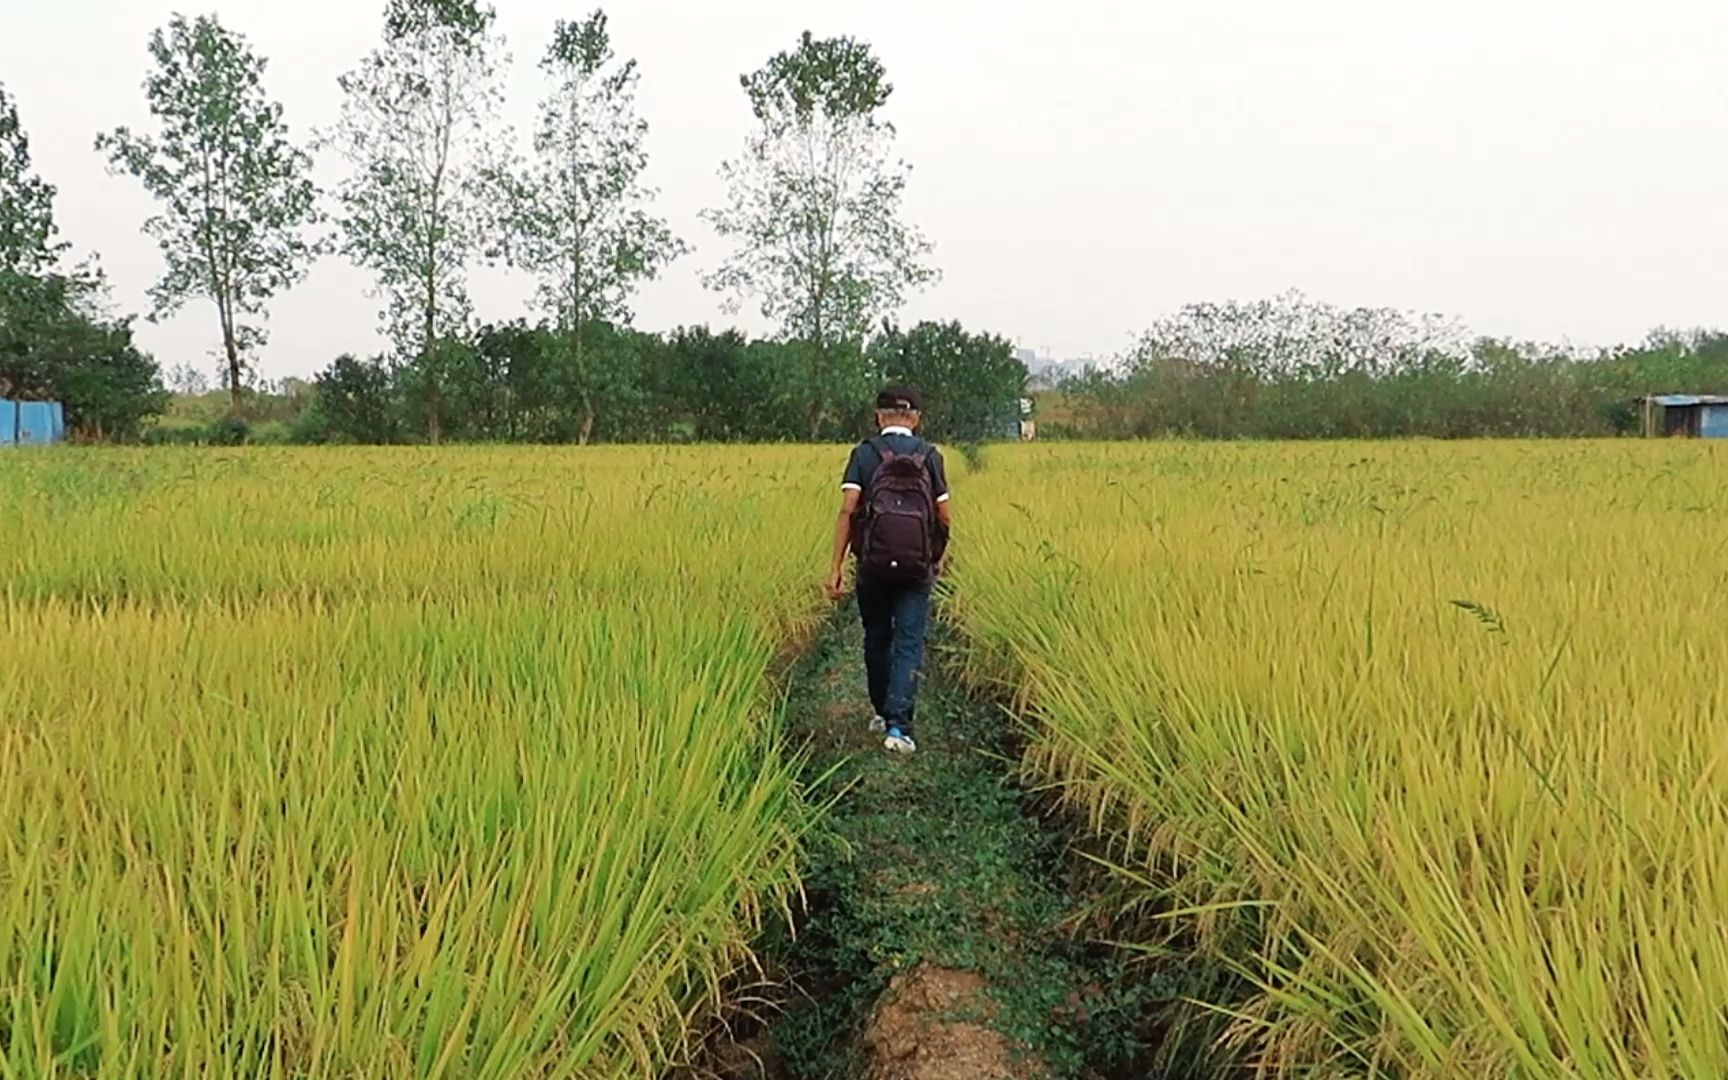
[1040,292,1728,439]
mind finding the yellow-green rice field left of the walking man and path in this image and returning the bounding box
[0,449,833,1080]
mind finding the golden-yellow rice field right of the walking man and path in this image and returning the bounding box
[950,442,1728,1078]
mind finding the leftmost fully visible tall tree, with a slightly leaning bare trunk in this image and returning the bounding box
[97,16,320,411]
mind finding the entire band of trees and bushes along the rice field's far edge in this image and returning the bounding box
[0,0,1728,442]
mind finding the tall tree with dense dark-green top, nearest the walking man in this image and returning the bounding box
[705,31,935,437]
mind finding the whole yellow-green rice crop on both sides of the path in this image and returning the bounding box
[0,442,1728,1080]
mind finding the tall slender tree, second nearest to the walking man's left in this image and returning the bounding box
[508,10,686,442]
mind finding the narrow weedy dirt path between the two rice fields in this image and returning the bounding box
[711,605,1158,1080]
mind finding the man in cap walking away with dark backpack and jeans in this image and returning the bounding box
[828,385,952,753]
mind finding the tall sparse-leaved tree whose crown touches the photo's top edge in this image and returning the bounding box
[330,0,501,441]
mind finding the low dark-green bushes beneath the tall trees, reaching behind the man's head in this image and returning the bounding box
[165,320,1026,444]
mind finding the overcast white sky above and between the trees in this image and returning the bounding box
[0,0,1728,377]
